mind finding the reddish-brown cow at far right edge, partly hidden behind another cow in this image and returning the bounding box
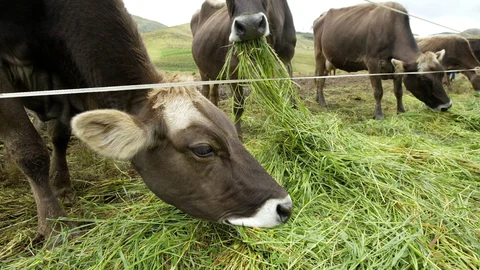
[416,35,480,92]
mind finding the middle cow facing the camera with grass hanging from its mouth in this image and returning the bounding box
[190,0,297,133]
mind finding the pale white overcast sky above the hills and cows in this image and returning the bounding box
[124,0,480,36]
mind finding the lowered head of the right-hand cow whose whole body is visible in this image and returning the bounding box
[392,50,452,111]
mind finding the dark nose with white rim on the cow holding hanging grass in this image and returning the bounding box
[232,13,270,41]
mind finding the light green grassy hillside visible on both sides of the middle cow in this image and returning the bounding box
[143,24,315,74]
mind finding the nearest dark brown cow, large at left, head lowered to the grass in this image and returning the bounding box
[0,0,292,236]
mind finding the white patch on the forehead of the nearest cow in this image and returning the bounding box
[164,96,208,133]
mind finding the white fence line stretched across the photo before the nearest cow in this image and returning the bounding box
[0,69,477,99]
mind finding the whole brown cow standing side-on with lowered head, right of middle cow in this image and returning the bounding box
[313,2,452,119]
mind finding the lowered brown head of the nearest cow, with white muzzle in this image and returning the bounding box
[72,85,292,227]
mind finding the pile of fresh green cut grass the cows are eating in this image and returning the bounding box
[0,37,480,269]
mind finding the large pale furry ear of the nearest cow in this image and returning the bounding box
[72,110,148,160]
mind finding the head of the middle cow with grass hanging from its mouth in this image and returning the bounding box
[227,0,270,42]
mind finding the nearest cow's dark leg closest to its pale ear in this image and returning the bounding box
[47,120,74,203]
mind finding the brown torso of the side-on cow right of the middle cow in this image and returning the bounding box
[314,2,418,71]
